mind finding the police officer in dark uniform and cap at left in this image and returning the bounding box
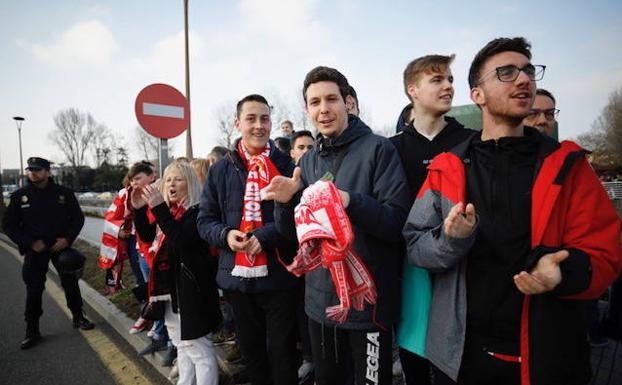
[2,157,95,349]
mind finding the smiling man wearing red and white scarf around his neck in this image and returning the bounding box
[197,94,298,385]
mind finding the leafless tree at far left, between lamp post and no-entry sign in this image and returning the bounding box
[49,108,100,168]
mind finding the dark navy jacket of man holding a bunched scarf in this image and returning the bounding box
[275,115,410,330]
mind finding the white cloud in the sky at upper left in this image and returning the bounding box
[18,20,119,68]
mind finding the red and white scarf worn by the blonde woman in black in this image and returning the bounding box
[147,206,187,302]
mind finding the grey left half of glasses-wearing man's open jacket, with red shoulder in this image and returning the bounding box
[404,146,477,381]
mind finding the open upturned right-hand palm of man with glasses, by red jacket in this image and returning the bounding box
[514,250,569,295]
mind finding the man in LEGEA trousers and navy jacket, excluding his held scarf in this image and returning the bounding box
[265,67,410,385]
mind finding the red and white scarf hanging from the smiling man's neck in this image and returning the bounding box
[231,140,281,278]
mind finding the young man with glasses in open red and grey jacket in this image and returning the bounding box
[404,37,621,385]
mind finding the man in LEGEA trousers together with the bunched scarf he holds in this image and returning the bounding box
[264,67,410,385]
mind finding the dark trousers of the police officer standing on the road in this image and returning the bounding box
[22,251,82,324]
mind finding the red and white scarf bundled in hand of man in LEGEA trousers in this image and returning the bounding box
[287,181,376,323]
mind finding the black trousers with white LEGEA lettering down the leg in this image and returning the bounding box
[309,319,392,385]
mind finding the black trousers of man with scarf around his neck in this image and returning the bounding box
[227,290,298,385]
